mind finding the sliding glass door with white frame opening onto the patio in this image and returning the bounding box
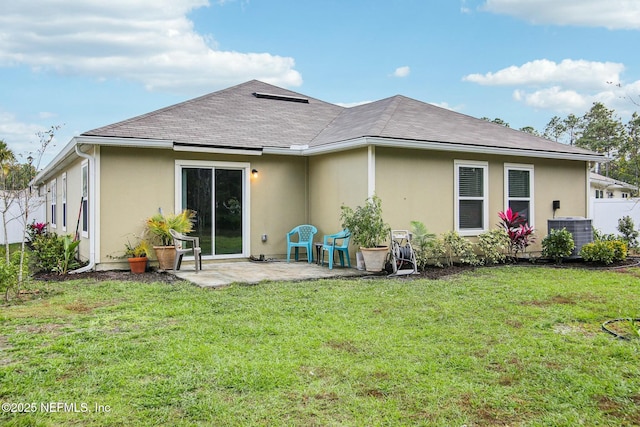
[176,163,248,258]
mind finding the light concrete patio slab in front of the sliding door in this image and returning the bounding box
[174,260,371,288]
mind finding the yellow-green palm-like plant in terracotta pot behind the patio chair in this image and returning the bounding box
[147,209,196,270]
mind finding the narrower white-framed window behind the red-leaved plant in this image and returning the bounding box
[505,164,533,226]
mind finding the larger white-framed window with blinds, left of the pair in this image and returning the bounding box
[456,162,488,235]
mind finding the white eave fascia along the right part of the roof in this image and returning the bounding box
[263,137,606,162]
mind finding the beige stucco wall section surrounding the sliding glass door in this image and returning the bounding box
[100,147,308,268]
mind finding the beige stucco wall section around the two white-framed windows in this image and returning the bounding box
[375,148,588,249]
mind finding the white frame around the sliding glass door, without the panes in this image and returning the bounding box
[174,160,251,259]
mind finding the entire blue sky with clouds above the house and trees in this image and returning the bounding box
[0,0,640,166]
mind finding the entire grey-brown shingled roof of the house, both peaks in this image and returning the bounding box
[82,80,601,160]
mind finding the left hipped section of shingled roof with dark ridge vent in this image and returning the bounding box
[82,80,344,149]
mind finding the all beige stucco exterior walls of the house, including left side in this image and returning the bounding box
[41,147,588,269]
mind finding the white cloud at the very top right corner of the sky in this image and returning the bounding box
[480,0,640,30]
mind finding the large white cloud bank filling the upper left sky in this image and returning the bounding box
[0,0,302,93]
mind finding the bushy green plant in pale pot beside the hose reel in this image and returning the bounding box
[340,196,391,271]
